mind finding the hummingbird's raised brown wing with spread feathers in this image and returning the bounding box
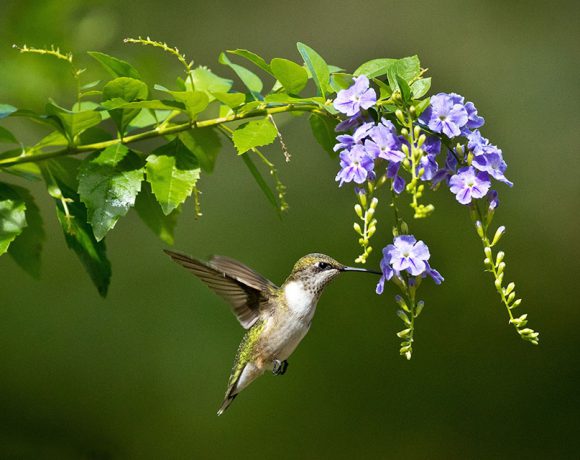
[165,249,276,329]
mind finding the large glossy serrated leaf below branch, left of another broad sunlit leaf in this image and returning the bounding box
[79,147,143,241]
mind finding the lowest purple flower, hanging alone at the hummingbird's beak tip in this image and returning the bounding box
[376,235,443,294]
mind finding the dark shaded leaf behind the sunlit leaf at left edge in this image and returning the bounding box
[8,183,45,278]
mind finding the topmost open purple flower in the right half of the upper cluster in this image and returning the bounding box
[420,93,468,138]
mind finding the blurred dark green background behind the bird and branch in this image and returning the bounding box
[0,0,580,459]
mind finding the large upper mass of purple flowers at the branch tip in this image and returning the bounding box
[334,81,513,208]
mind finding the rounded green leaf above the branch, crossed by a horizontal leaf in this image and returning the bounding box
[103,77,149,134]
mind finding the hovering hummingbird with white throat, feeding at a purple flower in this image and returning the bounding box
[165,250,381,415]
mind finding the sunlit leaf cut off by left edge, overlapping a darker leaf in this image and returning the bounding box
[0,182,27,255]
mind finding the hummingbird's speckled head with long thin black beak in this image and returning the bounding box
[289,253,381,293]
